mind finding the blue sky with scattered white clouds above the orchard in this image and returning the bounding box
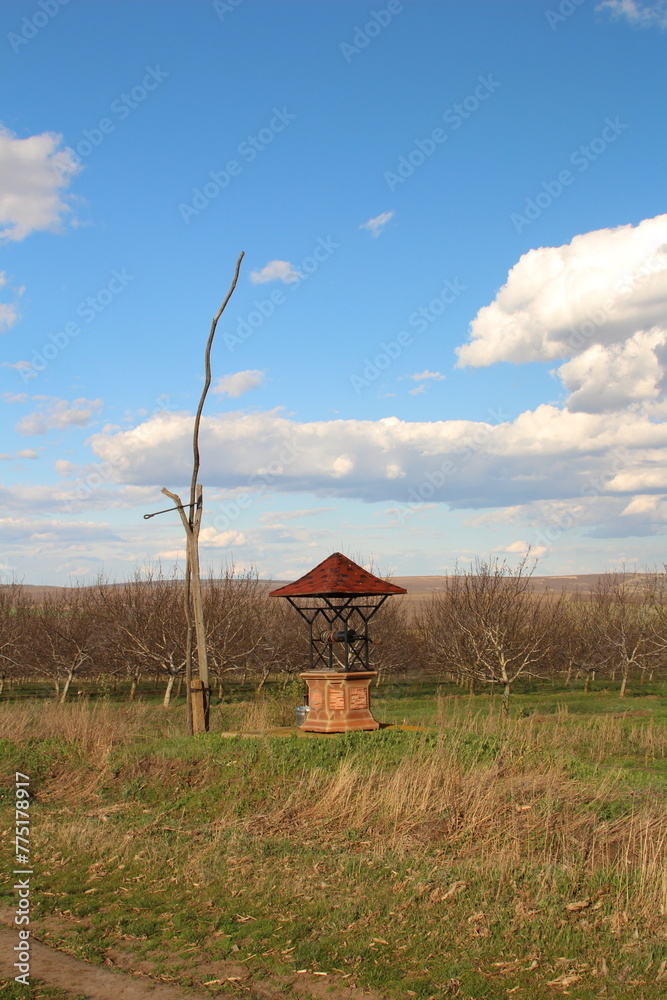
[0,0,667,584]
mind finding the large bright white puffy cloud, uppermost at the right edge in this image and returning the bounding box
[457,215,667,367]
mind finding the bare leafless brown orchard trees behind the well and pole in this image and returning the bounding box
[0,559,667,711]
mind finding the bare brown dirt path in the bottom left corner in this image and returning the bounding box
[0,927,217,1000]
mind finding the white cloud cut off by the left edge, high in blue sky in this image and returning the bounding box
[0,126,81,242]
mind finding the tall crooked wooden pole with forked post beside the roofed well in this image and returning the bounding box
[162,251,244,734]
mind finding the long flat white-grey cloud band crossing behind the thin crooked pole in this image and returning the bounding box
[85,405,667,508]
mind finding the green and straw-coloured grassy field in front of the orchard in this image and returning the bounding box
[0,684,667,1000]
